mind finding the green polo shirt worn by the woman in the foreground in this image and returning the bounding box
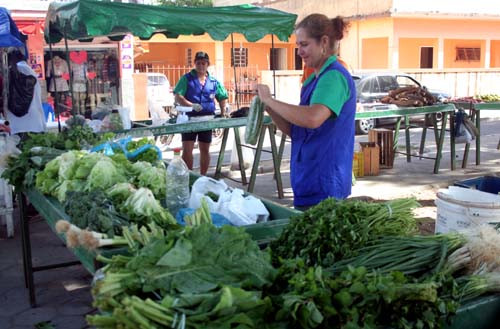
[304,56,350,116]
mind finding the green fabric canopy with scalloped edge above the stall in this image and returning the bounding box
[45,0,297,43]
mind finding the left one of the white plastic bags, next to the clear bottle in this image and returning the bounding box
[188,176,228,212]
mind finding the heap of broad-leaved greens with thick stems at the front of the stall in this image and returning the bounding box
[87,224,276,328]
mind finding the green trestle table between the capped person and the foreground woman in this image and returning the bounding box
[115,116,283,199]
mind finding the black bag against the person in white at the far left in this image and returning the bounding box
[9,64,37,117]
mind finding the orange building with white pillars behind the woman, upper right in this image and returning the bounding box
[224,0,500,70]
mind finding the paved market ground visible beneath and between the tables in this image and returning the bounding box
[0,117,500,329]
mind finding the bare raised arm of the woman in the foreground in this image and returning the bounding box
[257,85,332,130]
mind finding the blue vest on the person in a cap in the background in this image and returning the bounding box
[184,72,218,117]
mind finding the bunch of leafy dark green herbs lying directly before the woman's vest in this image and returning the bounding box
[271,198,418,266]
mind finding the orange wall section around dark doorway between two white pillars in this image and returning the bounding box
[399,38,438,68]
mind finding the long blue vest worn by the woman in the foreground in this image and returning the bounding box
[290,61,356,206]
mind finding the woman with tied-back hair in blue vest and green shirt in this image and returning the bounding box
[257,14,356,210]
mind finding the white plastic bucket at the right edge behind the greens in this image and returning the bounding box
[435,186,500,233]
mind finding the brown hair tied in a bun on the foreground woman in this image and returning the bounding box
[295,14,349,50]
